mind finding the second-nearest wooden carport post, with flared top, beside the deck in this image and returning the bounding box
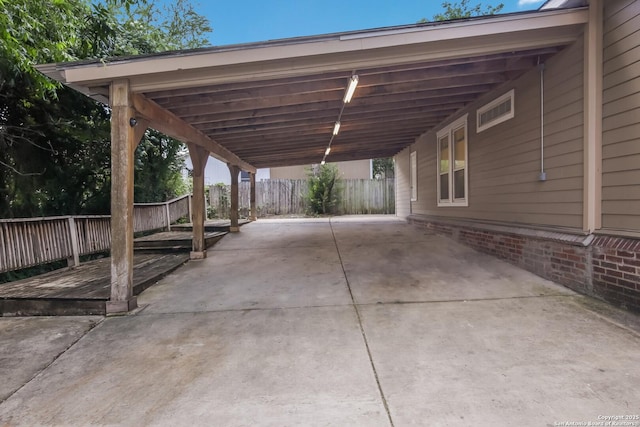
[187,143,209,259]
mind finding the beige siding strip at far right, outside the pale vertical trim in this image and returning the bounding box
[602,0,640,231]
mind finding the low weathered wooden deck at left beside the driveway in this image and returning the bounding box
[0,253,189,316]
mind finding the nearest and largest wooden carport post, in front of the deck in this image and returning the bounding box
[107,80,141,314]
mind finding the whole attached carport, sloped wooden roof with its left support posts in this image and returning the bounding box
[39,8,588,313]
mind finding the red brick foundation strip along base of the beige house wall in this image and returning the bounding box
[408,216,640,312]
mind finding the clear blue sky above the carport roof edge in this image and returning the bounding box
[193,0,544,45]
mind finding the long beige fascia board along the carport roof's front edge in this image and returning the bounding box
[52,9,588,90]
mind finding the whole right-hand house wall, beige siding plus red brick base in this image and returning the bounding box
[396,5,640,312]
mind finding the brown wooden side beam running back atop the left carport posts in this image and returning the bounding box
[133,94,256,172]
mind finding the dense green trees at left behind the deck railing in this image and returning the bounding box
[0,0,211,217]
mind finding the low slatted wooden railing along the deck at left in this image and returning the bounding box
[0,196,191,273]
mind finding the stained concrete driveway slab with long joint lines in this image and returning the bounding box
[0,217,640,426]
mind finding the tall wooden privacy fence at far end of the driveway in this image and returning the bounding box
[209,179,395,218]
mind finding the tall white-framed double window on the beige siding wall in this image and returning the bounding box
[437,114,469,206]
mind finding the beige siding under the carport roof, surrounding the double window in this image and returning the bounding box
[412,41,583,229]
